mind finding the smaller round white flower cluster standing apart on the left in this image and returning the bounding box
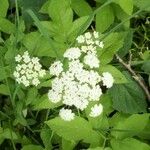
[13,51,46,87]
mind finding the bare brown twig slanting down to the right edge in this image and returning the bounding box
[116,55,150,102]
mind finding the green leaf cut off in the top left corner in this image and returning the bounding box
[0,0,9,17]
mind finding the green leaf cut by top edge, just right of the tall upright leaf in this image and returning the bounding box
[71,0,92,17]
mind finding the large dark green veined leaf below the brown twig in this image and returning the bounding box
[109,72,147,114]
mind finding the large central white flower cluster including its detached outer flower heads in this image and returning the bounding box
[48,32,114,121]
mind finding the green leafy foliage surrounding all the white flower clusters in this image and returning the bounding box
[0,0,150,150]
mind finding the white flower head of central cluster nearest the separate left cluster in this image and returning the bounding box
[49,61,63,76]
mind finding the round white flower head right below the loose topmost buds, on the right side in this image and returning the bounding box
[84,53,100,68]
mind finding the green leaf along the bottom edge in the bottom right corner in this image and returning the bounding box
[111,138,150,150]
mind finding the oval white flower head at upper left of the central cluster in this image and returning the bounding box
[64,47,81,60]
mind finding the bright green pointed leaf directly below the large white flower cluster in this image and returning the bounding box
[46,116,101,141]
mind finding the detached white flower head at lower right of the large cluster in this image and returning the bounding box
[89,104,103,118]
